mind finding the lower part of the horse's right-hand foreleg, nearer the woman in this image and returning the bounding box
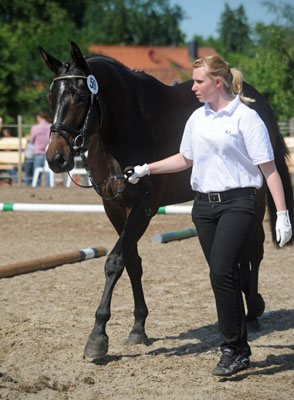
[125,246,148,344]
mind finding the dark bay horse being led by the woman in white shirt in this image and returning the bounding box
[40,43,293,358]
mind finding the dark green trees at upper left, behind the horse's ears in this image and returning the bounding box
[0,0,185,122]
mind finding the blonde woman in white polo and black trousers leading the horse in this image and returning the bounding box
[129,56,292,376]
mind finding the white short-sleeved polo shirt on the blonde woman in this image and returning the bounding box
[180,96,274,193]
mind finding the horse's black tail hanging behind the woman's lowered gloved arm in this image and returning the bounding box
[267,122,294,245]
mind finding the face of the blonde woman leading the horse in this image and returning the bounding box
[192,67,217,103]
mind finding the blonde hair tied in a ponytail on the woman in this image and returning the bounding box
[193,56,255,103]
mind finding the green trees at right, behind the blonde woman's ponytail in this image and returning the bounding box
[216,0,294,121]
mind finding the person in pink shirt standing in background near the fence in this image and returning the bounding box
[30,111,51,186]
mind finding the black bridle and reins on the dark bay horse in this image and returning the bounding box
[50,74,127,200]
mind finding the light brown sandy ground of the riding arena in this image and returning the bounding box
[0,185,294,400]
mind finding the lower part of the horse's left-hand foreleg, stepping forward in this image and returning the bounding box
[84,240,124,358]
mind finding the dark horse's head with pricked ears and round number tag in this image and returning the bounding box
[40,42,98,172]
